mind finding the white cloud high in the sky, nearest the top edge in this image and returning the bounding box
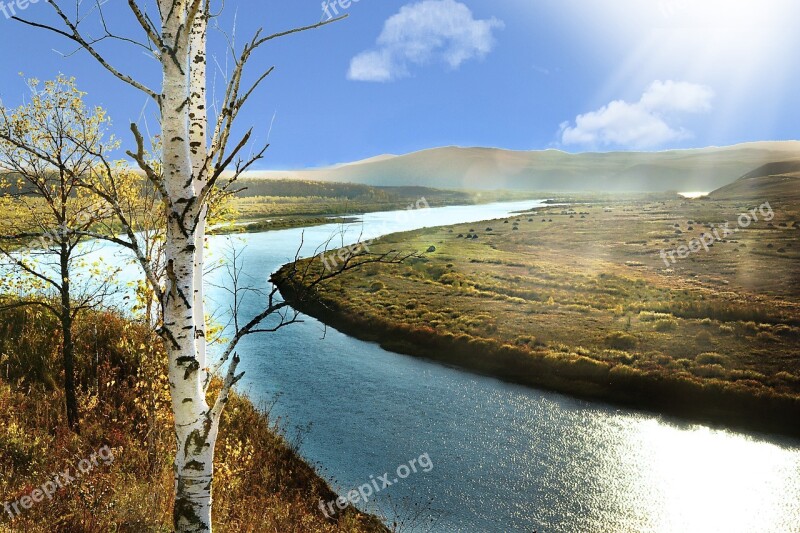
[347,0,504,82]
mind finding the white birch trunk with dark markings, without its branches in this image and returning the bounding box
[161,0,216,533]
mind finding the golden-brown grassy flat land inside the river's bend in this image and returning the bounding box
[276,196,800,435]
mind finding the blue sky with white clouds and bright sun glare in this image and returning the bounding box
[0,0,800,168]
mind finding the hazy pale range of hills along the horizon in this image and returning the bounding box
[247,141,800,192]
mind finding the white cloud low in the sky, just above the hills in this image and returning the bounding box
[561,81,714,148]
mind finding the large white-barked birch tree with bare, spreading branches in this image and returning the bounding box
[15,0,412,532]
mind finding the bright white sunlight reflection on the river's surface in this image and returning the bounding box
[580,417,800,533]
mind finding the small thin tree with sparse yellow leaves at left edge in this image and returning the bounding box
[0,76,116,432]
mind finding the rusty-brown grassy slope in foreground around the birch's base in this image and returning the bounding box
[0,309,387,533]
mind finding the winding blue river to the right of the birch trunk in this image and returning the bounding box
[202,202,800,533]
